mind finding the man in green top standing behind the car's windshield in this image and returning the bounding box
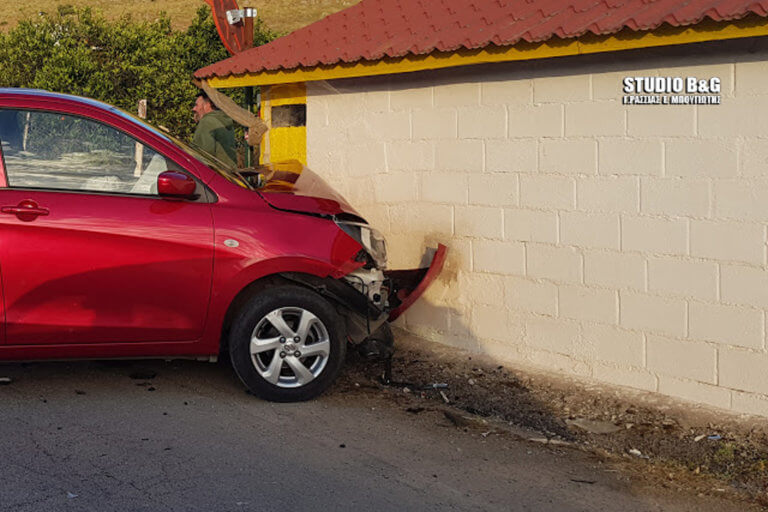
[192,92,237,167]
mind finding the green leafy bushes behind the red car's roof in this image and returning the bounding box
[0,6,275,142]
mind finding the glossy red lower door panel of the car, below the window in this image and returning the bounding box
[0,188,213,345]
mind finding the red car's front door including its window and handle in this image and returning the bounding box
[0,109,213,345]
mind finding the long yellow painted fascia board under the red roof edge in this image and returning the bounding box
[208,16,768,88]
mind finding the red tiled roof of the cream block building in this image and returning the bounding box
[196,0,768,78]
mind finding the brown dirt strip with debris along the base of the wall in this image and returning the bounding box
[339,336,768,506]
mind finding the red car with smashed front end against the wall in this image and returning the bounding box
[0,89,445,401]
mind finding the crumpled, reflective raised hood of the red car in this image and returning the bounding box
[256,160,362,220]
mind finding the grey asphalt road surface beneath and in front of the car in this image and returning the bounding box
[0,361,743,512]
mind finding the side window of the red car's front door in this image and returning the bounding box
[0,109,181,195]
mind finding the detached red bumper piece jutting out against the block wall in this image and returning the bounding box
[384,244,448,322]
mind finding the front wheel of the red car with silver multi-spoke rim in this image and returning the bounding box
[229,285,347,402]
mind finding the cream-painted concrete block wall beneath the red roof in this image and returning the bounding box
[307,42,768,415]
